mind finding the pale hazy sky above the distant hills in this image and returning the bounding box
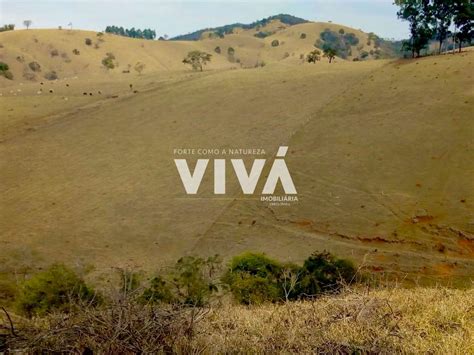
[0,0,408,39]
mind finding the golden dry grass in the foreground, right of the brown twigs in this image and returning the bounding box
[194,288,474,354]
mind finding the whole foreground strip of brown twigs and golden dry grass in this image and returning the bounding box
[1,288,474,354]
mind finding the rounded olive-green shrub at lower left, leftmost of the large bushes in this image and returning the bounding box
[16,264,98,316]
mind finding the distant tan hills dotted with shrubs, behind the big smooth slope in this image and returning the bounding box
[0,19,396,87]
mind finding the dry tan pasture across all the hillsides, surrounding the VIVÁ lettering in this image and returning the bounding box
[0,24,474,285]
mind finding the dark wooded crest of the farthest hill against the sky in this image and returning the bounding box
[171,14,309,41]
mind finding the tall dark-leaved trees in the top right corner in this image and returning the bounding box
[395,0,474,57]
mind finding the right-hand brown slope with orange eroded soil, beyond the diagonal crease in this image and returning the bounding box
[195,53,474,282]
